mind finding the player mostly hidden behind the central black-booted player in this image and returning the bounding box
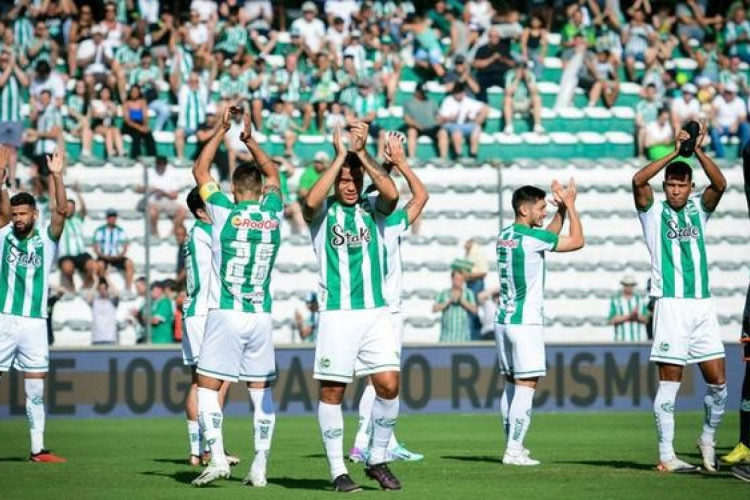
[349,134,429,462]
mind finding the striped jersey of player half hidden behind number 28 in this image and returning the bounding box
[182,220,211,318]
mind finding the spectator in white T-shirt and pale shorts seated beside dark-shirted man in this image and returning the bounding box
[438,84,489,159]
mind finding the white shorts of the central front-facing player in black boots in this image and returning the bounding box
[313,307,401,384]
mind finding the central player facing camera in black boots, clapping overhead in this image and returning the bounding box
[302,122,401,492]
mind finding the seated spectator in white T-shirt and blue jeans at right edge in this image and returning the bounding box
[711,82,750,158]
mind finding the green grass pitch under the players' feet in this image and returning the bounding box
[0,412,750,500]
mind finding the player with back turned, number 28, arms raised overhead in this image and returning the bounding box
[193,106,284,487]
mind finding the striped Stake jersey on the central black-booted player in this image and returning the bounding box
[310,193,386,311]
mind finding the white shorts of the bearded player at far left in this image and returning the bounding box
[0,314,49,373]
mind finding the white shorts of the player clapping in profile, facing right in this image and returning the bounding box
[495,324,547,379]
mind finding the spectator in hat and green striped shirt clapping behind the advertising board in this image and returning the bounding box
[432,270,477,342]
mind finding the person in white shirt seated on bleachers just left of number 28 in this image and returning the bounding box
[135,156,187,238]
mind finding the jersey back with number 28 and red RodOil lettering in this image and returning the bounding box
[201,183,283,313]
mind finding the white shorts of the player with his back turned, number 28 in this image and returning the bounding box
[197,309,276,382]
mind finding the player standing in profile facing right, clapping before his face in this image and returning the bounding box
[495,179,584,466]
